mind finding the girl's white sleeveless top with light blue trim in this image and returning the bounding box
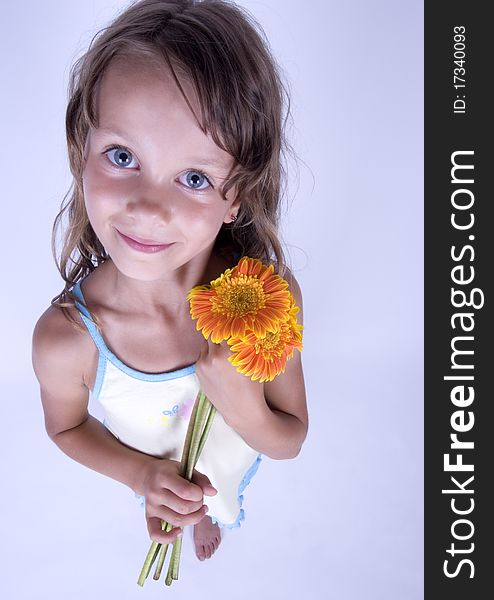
[72,280,261,528]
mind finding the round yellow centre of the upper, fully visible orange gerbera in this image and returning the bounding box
[211,275,266,317]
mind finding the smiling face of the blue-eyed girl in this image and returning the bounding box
[83,57,239,281]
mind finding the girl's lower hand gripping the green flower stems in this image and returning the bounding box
[138,458,217,544]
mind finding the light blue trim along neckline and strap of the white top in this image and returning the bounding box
[72,281,196,382]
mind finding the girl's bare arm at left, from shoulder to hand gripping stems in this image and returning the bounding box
[32,307,216,543]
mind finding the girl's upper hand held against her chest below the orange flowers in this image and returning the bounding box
[196,340,266,426]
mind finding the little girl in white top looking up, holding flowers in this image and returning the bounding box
[33,0,308,560]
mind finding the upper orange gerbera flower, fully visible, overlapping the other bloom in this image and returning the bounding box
[187,256,291,343]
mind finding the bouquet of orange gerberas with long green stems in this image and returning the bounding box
[137,257,303,586]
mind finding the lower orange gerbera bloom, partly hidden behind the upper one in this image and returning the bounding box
[228,319,302,383]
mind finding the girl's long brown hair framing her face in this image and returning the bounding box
[52,0,292,321]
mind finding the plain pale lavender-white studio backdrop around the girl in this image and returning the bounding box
[0,0,423,600]
